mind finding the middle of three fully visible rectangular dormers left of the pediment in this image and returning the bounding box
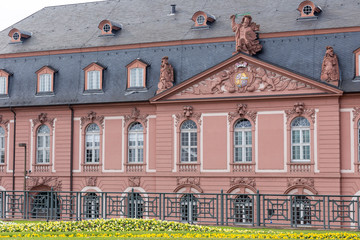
[84,63,106,92]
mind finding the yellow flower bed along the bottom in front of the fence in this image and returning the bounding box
[0,219,360,240]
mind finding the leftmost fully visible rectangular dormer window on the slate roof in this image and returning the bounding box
[36,66,57,94]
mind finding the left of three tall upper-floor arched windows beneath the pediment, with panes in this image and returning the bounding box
[180,120,197,162]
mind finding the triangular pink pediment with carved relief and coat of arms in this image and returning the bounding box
[155,54,342,100]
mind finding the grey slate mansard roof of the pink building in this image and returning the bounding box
[0,0,360,107]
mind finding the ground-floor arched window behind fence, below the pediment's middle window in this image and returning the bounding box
[232,194,253,224]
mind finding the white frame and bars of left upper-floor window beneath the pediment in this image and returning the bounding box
[180,120,198,163]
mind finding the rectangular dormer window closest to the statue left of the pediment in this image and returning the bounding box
[126,59,148,88]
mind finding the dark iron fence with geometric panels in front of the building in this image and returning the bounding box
[0,191,360,229]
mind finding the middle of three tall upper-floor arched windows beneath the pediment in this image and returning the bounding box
[234,119,252,162]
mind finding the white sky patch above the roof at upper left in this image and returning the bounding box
[0,0,99,31]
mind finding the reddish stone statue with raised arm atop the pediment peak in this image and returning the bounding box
[230,15,262,55]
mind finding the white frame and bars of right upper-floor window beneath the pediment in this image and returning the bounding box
[291,117,311,162]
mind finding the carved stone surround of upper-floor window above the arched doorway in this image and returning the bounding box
[30,113,56,173]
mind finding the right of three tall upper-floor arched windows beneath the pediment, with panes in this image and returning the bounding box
[291,117,310,161]
